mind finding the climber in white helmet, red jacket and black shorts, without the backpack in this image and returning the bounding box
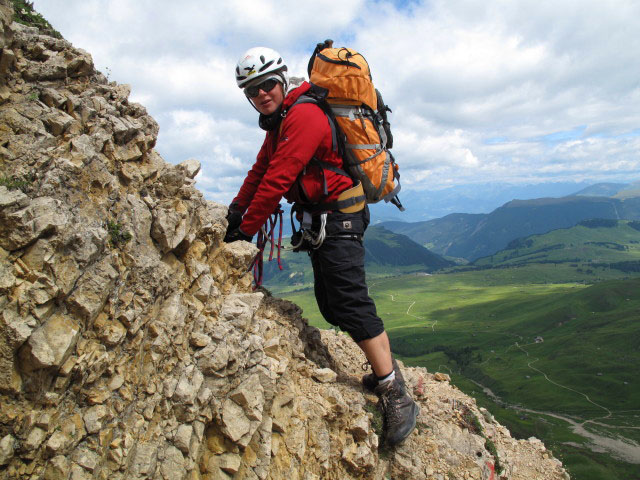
[224,47,419,446]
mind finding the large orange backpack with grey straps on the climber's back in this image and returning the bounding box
[308,40,404,210]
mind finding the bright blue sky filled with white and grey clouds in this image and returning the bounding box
[34,0,640,203]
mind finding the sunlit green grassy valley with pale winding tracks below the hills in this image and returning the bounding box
[282,263,640,480]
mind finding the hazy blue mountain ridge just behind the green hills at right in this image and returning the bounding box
[381,183,640,261]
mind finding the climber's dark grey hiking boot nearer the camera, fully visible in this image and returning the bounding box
[374,378,420,447]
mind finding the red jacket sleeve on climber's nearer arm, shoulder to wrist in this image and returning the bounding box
[240,103,331,235]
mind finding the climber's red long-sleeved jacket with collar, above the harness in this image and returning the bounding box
[233,82,353,235]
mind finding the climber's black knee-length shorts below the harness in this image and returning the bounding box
[310,208,384,342]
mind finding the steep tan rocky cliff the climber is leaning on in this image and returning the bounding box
[0,0,568,480]
